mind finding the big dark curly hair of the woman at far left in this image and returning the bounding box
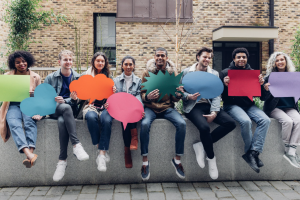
[7,51,35,70]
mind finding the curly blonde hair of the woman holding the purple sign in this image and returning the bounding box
[266,52,295,76]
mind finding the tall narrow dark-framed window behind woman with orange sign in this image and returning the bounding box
[94,14,116,67]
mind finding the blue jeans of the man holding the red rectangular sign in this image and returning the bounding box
[224,105,271,153]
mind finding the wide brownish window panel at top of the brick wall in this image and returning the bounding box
[116,0,193,22]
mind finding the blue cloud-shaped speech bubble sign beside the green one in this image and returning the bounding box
[20,83,57,117]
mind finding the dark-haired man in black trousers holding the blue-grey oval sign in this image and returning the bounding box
[181,47,236,179]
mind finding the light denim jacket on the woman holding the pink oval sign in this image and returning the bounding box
[114,72,143,104]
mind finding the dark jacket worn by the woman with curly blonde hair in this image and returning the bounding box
[260,76,299,117]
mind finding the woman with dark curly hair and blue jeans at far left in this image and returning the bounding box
[0,51,42,168]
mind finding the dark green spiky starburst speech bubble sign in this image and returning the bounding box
[142,70,183,101]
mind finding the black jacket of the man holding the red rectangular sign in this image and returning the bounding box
[219,61,262,107]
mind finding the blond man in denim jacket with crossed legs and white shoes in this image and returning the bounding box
[44,50,89,181]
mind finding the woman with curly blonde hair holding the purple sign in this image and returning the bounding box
[261,52,300,168]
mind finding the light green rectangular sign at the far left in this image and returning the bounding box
[0,75,30,102]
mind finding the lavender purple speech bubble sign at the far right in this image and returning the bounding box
[269,72,300,103]
